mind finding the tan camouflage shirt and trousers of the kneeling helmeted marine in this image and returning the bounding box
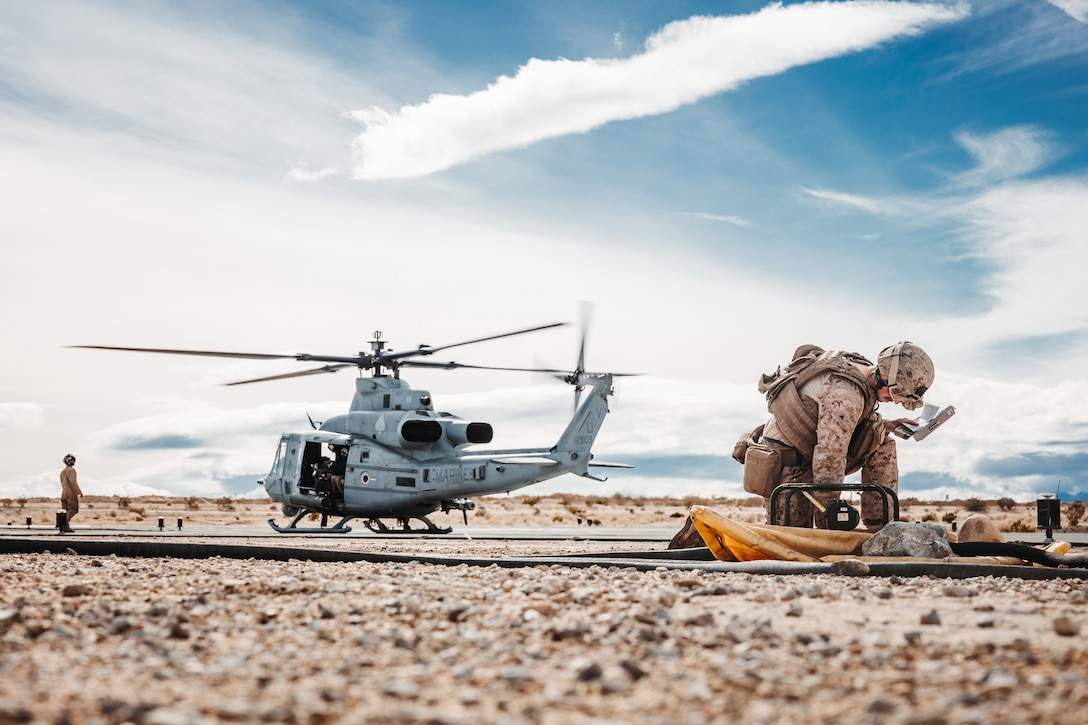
[763,372,899,529]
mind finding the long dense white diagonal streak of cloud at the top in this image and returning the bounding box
[350,2,967,180]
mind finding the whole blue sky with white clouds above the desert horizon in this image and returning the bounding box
[0,0,1088,500]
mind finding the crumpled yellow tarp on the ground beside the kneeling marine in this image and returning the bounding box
[688,506,1068,564]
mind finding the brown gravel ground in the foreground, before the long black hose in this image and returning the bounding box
[0,533,1088,725]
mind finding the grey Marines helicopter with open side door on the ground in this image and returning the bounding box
[73,322,631,533]
